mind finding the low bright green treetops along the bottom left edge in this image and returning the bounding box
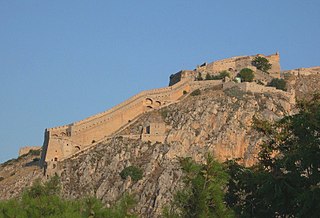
[0,177,137,218]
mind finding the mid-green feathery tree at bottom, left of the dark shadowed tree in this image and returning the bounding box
[163,155,234,218]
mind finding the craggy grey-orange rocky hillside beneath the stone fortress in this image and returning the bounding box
[0,67,320,217]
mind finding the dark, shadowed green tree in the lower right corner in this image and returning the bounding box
[226,95,320,217]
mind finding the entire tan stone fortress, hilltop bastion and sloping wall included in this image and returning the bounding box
[40,53,290,175]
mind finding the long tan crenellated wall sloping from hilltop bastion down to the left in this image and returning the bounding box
[42,80,191,163]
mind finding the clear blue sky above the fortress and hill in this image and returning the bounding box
[0,0,320,162]
